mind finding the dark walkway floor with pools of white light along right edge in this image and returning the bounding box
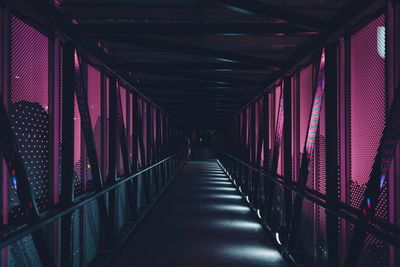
[113,161,286,267]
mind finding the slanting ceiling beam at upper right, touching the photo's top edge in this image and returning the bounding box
[211,0,326,30]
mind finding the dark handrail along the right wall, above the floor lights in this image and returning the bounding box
[222,152,400,246]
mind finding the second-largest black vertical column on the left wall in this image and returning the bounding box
[108,77,117,241]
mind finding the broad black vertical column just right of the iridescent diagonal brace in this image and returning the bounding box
[325,43,339,267]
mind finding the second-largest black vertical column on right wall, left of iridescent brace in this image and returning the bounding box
[282,76,292,226]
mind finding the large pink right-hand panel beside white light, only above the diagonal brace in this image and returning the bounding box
[350,16,386,207]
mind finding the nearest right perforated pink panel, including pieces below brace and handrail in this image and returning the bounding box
[350,16,388,266]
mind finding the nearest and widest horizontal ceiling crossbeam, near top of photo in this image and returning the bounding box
[74,22,318,37]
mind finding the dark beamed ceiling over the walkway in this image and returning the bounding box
[60,0,351,127]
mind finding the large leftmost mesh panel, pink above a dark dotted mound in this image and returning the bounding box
[9,16,50,214]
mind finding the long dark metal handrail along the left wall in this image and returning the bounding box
[0,152,181,248]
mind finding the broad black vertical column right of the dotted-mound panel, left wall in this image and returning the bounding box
[60,43,75,267]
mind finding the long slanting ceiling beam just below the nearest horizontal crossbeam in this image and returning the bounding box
[97,36,284,68]
